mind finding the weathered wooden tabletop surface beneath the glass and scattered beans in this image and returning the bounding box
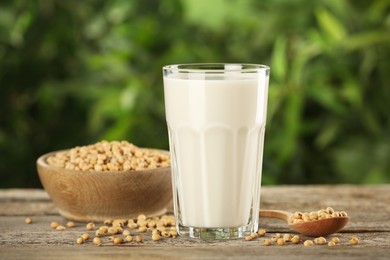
[0,184,390,259]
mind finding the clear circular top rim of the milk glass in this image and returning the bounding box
[163,63,270,73]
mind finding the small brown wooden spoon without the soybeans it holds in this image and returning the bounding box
[259,210,349,237]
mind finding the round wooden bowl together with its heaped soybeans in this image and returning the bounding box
[37,141,172,222]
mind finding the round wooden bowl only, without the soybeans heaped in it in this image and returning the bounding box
[37,150,172,222]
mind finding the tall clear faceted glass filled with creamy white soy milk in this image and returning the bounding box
[163,63,270,239]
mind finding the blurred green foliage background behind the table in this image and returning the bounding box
[0,0,390,188]
